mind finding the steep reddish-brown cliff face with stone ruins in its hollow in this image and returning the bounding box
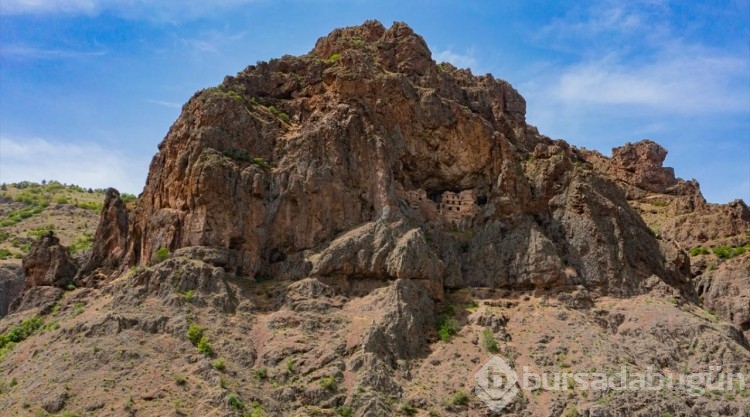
[113,22,679,294]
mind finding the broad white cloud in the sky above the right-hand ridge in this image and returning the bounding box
[548,47,750,114]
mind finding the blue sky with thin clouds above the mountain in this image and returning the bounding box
[0,0,750,202]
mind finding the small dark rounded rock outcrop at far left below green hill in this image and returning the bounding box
[22,231,78,289]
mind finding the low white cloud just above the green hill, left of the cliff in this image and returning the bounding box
[0,137,147,194]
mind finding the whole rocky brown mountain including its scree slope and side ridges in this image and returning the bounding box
[0,21,750,416]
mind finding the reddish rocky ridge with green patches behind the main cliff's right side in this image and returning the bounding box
[581,140,750,337]
